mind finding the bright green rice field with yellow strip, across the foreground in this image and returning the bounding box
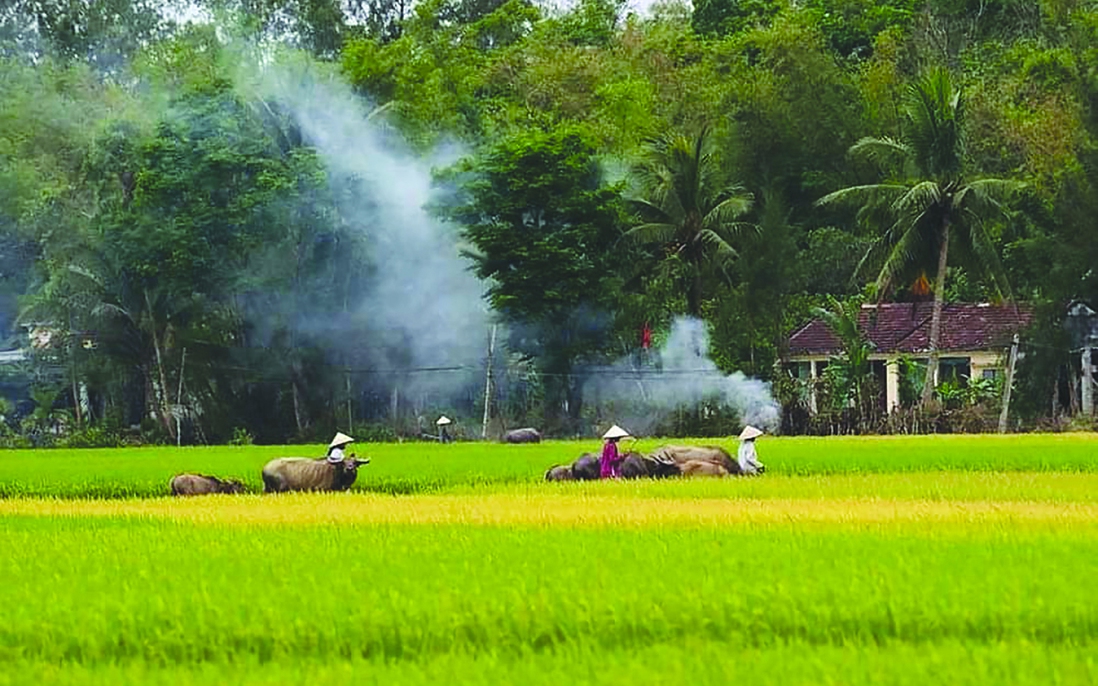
[0,435,1098,685]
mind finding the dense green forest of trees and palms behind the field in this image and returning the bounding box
[0,0,1098,445]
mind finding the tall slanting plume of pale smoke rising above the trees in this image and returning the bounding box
[251,61,489,402]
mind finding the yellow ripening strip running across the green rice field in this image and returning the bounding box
[8,493,1098,528]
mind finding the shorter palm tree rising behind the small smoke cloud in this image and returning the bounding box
[626,128,752,317]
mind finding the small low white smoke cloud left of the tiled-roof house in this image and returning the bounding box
[584,317,781,436]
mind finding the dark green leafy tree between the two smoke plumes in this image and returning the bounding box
[447,127,624,425]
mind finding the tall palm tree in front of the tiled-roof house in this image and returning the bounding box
[817,68,1023,404]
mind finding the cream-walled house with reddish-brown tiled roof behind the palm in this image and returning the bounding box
[788,302,1033,409]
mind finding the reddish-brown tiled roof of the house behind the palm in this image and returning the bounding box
[789,302,1033,356]
